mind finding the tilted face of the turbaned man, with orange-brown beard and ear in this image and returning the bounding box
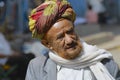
[46,19,82,59]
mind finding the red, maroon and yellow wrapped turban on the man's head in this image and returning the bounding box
[29,0,75,39]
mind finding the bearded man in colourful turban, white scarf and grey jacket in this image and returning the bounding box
[26,0,119,80]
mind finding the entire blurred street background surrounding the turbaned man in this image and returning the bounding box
[0,0,120,80]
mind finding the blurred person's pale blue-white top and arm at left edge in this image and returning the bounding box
[0,32,19,65]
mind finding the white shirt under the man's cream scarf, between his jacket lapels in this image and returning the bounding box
[57,65,96,80]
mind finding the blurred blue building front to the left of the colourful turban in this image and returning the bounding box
[0,0,42,33]
